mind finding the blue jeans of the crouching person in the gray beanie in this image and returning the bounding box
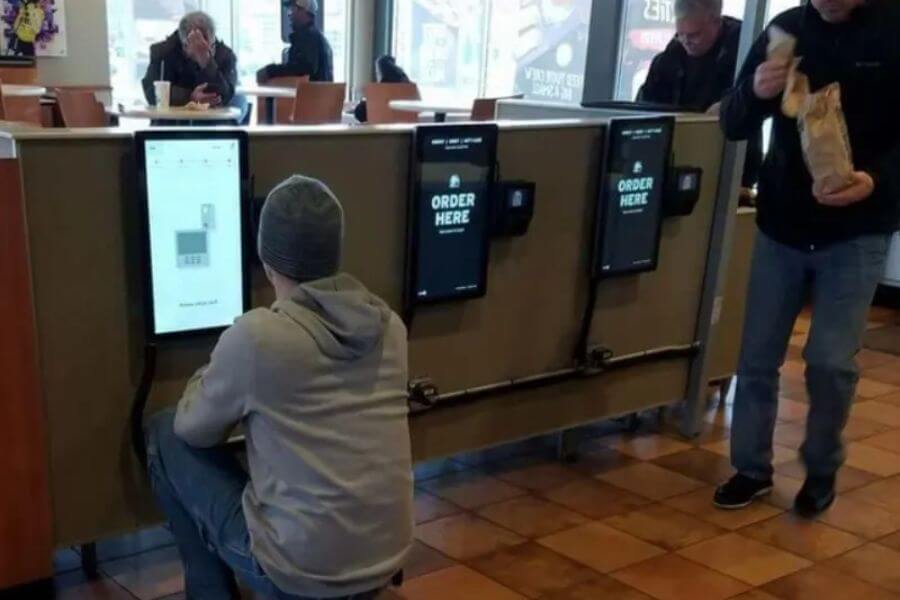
[146,410,377,600]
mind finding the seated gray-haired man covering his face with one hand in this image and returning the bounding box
[141,11,241,106]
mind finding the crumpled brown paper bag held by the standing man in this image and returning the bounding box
[797,83,854,195]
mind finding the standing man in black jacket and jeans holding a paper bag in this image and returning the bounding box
[715,0,900,517]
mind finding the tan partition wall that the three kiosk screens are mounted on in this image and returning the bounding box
[10,120,723,545]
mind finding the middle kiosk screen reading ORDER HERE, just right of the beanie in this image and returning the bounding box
[407,125,497,305]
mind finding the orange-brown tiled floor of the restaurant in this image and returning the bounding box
[51,310,900,600]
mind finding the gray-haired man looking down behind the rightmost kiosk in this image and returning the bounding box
[637,0,762,188]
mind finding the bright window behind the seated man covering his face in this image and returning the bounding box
[107,0,351,105]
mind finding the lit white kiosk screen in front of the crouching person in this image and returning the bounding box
[136,132,249,339]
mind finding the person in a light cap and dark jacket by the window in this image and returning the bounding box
[256,0,334,84]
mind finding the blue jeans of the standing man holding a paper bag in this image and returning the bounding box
[731,232,891,480]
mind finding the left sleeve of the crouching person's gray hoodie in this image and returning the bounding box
[175,319,255,448]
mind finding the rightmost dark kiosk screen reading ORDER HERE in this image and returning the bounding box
[592,117,675,279]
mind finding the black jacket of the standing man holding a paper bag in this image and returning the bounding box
[722,0,900,248]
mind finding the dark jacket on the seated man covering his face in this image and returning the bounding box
[141,31,237,106]
